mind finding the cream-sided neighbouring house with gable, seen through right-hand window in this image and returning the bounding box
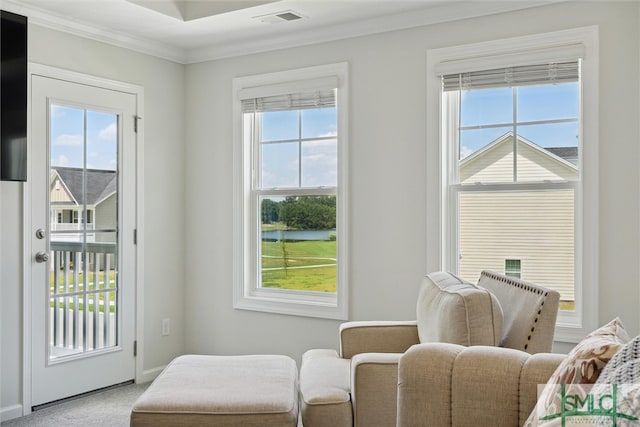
[459,132,578,301]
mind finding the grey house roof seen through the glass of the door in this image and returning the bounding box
[51,167,117,205]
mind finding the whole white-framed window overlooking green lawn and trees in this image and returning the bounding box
[234,64,348,319]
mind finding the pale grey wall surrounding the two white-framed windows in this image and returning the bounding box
[185,2,640,360]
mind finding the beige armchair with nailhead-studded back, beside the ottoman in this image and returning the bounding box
[300,271,559,427]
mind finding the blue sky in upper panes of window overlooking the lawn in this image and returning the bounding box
[262,107,338,188]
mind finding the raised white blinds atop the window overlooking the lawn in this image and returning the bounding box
[239,77,338,113]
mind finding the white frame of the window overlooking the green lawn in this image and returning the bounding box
[233,63,349,320]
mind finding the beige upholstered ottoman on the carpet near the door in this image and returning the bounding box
[131,355,298,427]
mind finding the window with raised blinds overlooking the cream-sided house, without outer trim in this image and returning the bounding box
[441,59,581,309]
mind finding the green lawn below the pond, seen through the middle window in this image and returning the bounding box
[262,240,336,292]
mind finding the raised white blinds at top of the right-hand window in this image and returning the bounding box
[442,60,580,91]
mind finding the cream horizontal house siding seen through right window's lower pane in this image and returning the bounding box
[459,190,575,301]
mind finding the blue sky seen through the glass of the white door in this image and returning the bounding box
[50,105,118,170]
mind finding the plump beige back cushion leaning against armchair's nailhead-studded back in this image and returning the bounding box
[416,272,503,346]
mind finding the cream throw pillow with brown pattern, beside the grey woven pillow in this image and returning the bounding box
[525,317,631,426]
